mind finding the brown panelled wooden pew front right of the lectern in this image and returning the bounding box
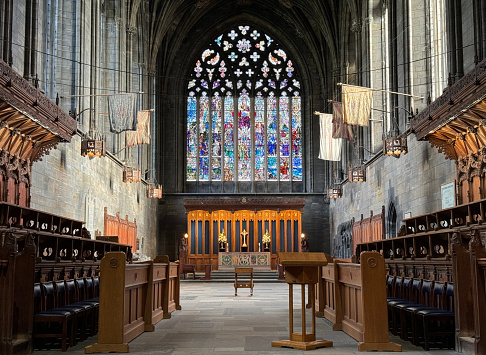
[316,252,401,351]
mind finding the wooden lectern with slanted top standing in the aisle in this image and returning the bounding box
[272,253,332,350]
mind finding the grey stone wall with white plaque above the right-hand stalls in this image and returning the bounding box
[330,135,456,258]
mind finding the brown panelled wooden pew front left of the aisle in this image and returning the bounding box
[85,252,181,354]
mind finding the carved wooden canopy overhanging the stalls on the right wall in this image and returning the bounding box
[411,59,486,160]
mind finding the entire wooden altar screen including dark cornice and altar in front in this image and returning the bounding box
[184,197,305,271]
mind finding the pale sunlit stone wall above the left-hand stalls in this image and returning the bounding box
[31,135,159,257]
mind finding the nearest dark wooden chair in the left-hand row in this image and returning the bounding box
[33,284,76,351]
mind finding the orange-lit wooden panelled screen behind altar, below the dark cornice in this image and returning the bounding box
[187,210,302,270]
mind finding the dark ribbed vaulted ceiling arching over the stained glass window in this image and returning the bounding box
[135,0,362,96]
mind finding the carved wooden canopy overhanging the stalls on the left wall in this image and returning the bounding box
[0,60,77,162]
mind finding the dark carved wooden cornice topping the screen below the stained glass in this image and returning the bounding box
[184,197,305,212]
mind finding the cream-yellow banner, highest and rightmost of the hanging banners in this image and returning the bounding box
[342,84,373,126]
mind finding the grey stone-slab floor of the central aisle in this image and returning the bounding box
[34,281,457,355]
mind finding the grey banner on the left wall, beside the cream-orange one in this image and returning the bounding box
[108,94,137,133]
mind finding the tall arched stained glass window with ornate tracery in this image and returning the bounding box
[186,26,302,181]
